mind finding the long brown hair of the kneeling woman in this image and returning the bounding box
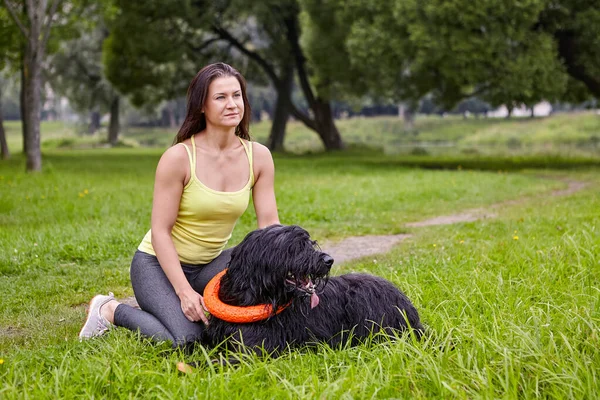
[173,62,252,144]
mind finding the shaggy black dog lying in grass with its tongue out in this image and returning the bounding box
[204,225,424,354]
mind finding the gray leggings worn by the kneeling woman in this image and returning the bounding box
[114,249,232,347]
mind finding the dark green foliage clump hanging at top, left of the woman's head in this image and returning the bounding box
[102,0,202,106]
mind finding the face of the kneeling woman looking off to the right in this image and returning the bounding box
[203,76,244,128]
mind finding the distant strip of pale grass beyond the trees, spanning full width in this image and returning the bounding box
[5,111,600,159]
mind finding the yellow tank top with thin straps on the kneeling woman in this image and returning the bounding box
[138,136,254,264]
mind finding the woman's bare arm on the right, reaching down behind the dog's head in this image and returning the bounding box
[252,142,279,228]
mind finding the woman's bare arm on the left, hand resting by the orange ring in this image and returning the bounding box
[152,146,208,324]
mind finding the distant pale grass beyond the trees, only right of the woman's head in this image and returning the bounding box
[252,111,600,157]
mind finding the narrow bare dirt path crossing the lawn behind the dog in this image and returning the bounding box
[122,179,587,307]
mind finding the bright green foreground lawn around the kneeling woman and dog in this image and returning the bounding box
[0,149,600,399]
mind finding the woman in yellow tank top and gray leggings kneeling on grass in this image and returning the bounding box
[79,63,279,346]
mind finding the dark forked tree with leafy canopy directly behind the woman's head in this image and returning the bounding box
[106,0,343,149]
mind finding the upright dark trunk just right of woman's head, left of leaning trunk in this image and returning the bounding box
[267,66,294,151]
